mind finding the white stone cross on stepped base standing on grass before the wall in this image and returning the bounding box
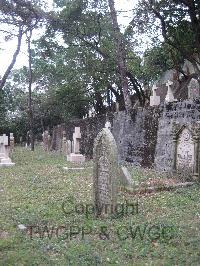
[67,127,85,163]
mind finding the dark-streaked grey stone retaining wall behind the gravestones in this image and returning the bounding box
[51,98,200,170]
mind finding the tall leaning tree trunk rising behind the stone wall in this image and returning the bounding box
[108,0,132,112]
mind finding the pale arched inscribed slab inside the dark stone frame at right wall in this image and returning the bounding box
[176,128,194,174]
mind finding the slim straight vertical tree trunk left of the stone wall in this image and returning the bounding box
[27,29,34,151]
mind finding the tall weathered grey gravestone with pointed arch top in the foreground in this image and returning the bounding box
[93,124,119,214]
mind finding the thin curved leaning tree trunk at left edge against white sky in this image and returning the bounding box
[0,26,23,91]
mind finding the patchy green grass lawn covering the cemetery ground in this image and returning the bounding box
[0,147,200,265]
